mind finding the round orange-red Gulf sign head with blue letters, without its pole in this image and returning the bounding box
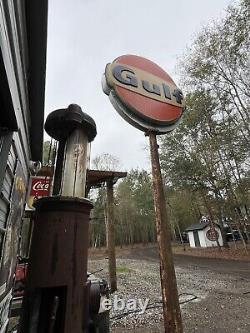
[102,55,185,134]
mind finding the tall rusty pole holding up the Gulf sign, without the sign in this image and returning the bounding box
[149,132,183,333]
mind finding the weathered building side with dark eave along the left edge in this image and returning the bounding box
[0,0,48,333]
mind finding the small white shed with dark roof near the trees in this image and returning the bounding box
[186,221,222,247]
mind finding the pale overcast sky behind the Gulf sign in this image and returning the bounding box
[46,0,232,170]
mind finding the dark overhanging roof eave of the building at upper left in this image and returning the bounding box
[25,0,48,161]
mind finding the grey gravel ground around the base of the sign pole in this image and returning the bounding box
[88,258,250,333]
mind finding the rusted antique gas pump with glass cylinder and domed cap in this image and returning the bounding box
[19,104,96,333]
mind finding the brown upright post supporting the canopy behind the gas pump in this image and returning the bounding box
[107,180,117,293]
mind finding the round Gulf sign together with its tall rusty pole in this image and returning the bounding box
[102,54,185,333]
